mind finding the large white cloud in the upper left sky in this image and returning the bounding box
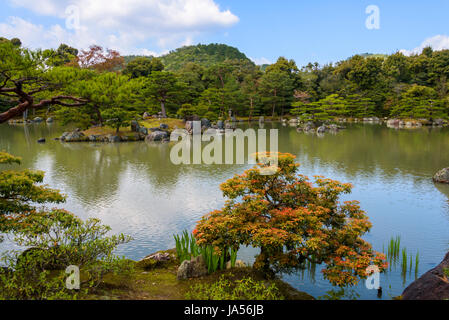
[0,0,239,54]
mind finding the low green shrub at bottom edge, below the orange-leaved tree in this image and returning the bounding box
[186,276,284,301]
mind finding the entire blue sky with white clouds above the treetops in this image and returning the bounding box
[0,0,449,66]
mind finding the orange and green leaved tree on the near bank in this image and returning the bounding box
[194,153,387,287]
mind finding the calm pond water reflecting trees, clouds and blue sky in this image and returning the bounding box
[0,124,449,299]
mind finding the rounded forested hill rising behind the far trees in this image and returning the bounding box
[125,44,250,71]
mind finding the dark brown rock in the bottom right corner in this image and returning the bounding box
[402,253,449,300]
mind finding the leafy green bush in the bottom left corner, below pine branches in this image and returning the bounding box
[0,210,133,300]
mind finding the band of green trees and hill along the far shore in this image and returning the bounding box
[0,38,449,127]
